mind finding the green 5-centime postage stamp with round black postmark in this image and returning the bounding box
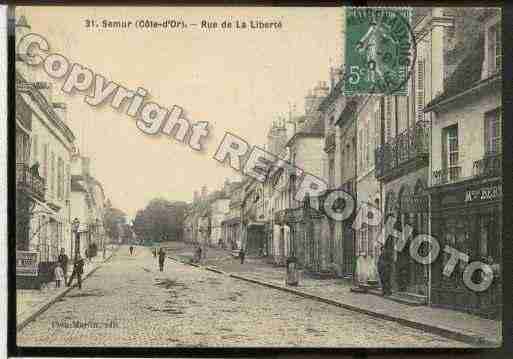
[344,7,416,96]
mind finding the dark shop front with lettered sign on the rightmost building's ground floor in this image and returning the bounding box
[430,178,502,318]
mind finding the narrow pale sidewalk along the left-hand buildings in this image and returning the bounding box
[16,248,117,330]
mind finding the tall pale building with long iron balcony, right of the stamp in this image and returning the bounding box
[375,8,456,303]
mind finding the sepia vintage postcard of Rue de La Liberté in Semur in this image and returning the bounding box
[12,6,503,353]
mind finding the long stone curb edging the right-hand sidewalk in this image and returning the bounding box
[170,260,501,348]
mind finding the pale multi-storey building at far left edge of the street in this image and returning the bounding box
[15,16,75,278]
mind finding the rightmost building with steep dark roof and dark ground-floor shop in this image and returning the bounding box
[424,9,503,317]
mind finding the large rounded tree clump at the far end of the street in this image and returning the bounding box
[133,198,187,241]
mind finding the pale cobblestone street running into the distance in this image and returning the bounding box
[17,247,467,347]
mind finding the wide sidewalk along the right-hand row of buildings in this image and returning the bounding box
[167,243,502,346]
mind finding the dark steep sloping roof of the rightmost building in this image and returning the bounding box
[426,35,485,110]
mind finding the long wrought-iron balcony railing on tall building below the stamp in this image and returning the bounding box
[375,121,429,178]
